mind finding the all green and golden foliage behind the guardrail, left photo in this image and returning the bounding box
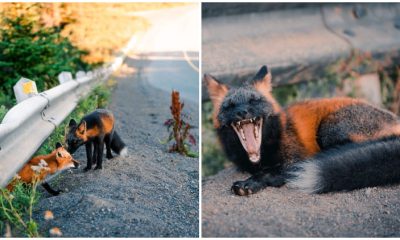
[0,2,184,121]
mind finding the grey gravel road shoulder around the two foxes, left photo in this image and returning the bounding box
[35,56,199,237]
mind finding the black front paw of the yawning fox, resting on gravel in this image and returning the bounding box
[231,168,285,196]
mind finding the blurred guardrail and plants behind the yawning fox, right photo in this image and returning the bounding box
[202,3,400,176]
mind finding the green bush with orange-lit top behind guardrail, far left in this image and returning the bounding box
[0,3,91,120]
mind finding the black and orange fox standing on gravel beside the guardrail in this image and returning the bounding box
[66,109,128,171]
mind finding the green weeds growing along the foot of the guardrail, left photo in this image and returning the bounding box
[0,80,115,237]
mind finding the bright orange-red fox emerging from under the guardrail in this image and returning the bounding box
[7,143,79,196]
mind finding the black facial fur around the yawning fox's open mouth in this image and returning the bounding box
[217,87,281,173]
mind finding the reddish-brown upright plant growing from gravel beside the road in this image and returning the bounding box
[164,91,198,157]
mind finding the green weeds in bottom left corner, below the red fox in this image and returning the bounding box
[0,173,40,237]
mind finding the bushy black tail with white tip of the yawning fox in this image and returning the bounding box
[287,136,400,193]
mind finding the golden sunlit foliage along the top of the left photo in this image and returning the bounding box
[0,2,188,64]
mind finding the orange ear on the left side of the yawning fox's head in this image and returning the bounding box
[204,74,229,128]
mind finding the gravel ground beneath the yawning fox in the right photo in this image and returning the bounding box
[202,167,400,237]
